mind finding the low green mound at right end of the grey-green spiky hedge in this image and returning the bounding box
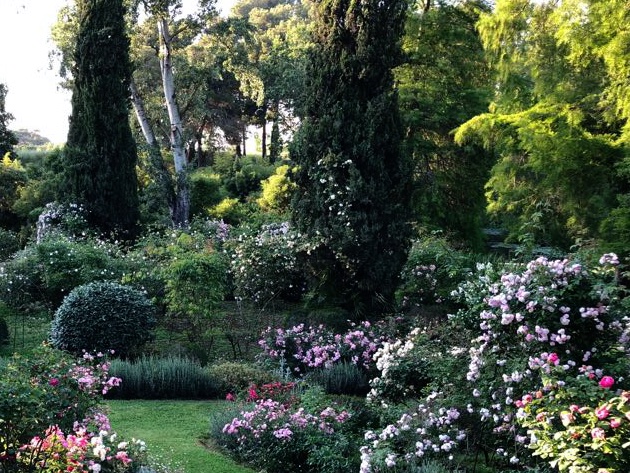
[206,361,276,397]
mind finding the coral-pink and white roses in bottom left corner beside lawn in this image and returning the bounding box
[17,414,146,473]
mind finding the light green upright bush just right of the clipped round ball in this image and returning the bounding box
[124,226,230,361]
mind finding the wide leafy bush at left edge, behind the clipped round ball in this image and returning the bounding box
[0,234,125,311]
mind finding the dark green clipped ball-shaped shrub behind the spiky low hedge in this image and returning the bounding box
[50,282,156,358]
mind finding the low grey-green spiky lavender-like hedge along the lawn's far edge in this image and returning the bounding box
[109,355,218,399]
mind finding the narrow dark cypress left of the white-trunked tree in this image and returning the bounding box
[62,0,139,238]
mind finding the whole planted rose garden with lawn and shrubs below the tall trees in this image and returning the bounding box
[0,208,630,473]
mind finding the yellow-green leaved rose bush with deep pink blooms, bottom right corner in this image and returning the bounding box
[517,368,630,473]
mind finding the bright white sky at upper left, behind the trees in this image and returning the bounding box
[0,0,234,144]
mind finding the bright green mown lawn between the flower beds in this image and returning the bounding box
[106,400,253,473]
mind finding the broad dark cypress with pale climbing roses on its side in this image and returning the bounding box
[291,0,411,315]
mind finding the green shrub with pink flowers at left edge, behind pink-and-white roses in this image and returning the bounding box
[0,345,120,471]
